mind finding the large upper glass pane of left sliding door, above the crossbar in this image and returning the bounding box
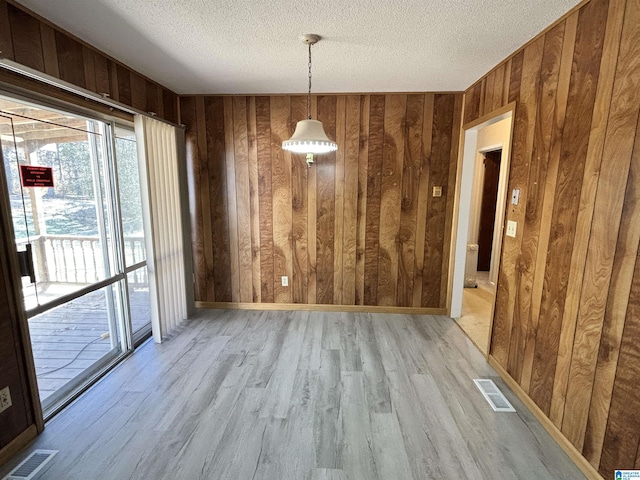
[0,101,113,311]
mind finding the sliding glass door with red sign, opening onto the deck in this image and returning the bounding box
[0,97,150,417]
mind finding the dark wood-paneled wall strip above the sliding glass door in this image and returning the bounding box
[0,0,178,122]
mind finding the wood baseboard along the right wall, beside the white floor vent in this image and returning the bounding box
[487,355,604,480]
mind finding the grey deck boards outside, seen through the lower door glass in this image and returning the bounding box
[29,288,150,401]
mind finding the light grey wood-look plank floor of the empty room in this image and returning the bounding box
[0,310,584,480]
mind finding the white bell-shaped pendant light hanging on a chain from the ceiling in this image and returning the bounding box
[282,34,338,167]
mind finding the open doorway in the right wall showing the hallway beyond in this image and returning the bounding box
[450,107,513,355]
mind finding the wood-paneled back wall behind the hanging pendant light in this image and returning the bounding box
[180,94,462,308]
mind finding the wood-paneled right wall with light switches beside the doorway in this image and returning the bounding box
[464,0,640,478]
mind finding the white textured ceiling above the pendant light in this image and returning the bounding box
[19,0,579,94]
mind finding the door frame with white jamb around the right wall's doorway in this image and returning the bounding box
[447,102,516,357]
